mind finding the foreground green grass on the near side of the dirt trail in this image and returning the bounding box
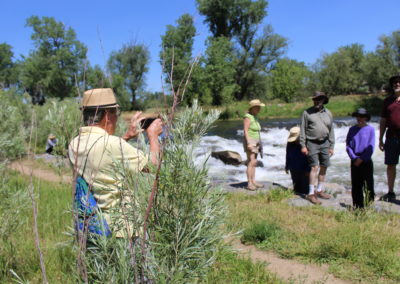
[0,168,281,284]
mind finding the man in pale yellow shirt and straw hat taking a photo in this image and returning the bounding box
[68,88,162,237]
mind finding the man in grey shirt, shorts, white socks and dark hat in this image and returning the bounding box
[300,92,335,204]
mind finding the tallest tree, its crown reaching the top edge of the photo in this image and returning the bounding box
[197,0,287,100]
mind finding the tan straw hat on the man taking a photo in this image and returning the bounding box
[81,88,118,109]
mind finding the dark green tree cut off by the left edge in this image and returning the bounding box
[0,43,17,88]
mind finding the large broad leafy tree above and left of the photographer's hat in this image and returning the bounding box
[20,16,87,103]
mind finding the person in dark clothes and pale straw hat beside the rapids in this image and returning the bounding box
[285,126,310,194]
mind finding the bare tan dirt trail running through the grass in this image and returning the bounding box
[9,160,351,284]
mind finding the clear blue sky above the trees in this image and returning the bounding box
[0,0,400,91]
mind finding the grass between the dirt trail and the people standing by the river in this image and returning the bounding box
[227,190,400,283]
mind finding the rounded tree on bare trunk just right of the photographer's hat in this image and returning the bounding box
[107,43,150,109]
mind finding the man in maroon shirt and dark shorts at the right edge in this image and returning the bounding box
[379,75,400,201]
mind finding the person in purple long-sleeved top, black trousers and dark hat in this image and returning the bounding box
[346,108,375,208]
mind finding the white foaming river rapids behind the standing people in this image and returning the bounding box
[196,117,390,193]
